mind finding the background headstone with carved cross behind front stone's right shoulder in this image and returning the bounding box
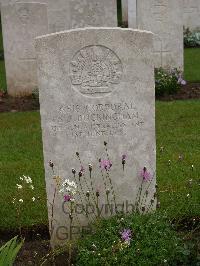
[129,0,183,70]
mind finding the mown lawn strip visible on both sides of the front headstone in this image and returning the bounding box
[0,100,200,229]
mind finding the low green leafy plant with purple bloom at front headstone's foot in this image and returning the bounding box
[76,212,197,266]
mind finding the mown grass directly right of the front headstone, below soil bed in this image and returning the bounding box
[156,100,200,217]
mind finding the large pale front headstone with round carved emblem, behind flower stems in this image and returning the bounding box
[36,28,156,245]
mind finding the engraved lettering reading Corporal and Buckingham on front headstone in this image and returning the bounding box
[49,102,144,139]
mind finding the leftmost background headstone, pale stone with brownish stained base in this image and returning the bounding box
[1,3,47,96]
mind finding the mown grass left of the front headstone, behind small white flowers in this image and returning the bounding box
[0,112,47,228]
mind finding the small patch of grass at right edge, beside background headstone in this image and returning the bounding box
[184,48,200,82]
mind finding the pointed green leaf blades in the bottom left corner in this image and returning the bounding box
[0,236,24,266]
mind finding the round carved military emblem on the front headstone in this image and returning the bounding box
[70,45,122,96]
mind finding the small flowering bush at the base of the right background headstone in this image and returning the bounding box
[155,68,186,96]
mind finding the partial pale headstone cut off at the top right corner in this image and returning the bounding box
[183,0,200,31]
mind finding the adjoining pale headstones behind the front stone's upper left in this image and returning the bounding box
[1,0,117,96]
